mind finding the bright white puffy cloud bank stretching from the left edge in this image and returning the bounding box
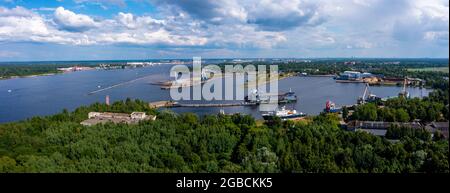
[0,7,208,46]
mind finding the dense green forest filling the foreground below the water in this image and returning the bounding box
[0,99,449,173]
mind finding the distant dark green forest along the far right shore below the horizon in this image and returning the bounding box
[219,58,449,90]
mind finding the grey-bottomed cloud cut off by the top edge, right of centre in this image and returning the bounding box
[153,0,323,31]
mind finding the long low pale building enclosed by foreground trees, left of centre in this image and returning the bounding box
[80,112,156,126]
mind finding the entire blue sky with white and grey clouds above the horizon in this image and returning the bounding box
[0,0,449,61]
